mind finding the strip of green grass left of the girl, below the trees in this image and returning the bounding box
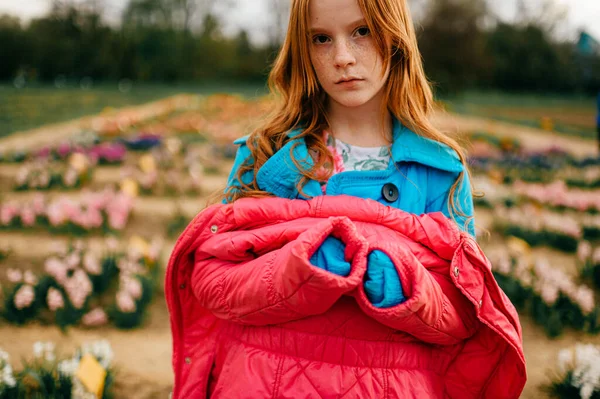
[0,82,265,137]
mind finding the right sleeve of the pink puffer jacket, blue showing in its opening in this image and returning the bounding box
[355,236,478,345]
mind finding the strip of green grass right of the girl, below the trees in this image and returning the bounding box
[440,91,597,139]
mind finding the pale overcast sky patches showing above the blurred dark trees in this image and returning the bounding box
[0,0,600,42]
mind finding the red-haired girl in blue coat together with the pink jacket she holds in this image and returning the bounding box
[165,0,526,399]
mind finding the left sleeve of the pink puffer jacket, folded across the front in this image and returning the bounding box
[192,217,367,325]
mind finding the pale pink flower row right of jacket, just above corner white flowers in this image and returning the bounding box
[488,245,600,337]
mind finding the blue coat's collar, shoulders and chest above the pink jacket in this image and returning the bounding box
[227,120,475,236]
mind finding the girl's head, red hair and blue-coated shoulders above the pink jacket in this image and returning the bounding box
[226,0,474,239]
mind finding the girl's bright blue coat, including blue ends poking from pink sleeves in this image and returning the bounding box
[227,121,475,308]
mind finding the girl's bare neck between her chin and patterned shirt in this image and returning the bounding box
[327,91,392,147]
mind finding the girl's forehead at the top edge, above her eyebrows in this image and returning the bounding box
[309,0,364,28]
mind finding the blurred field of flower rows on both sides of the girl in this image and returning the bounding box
[0,95,600,399]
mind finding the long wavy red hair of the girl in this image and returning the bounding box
[225,0,468,228]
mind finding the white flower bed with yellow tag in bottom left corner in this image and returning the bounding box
[0,341,115,399]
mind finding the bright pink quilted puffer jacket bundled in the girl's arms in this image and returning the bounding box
[165,196,526,399]
